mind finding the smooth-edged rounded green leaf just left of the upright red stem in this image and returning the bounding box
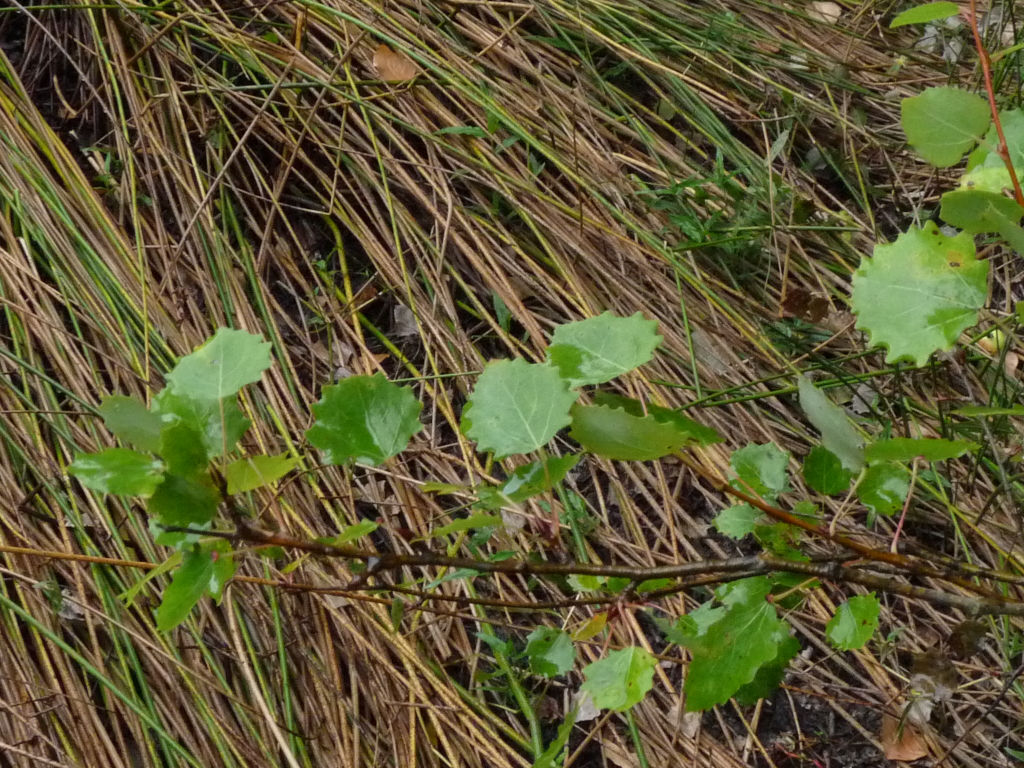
[900,86,991,168]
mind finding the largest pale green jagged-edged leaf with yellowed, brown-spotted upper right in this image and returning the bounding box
[850,221,988,366]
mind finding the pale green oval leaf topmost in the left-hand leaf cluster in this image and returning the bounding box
[167,328,270,400]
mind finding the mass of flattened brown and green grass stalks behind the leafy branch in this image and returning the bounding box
[0,0,1019,766]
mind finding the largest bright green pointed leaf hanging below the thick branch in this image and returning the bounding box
[684,577,790,712]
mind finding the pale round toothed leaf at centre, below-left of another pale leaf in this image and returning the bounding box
[462,359,577,459]
